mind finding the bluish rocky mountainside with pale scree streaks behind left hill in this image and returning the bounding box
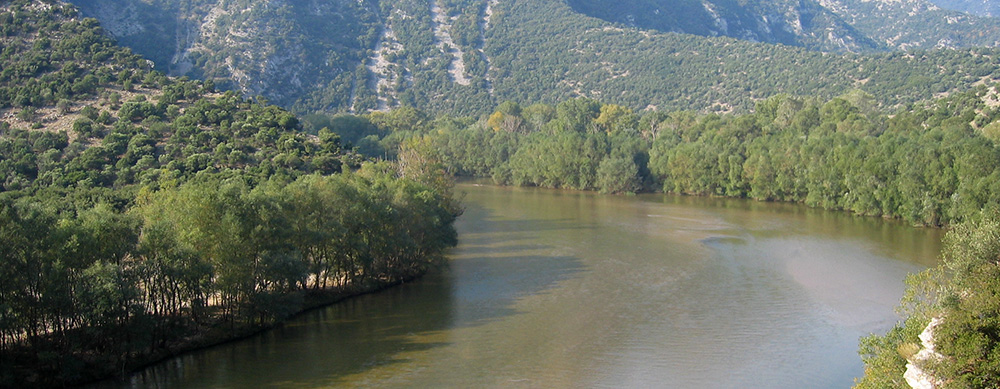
[72,0,496,112]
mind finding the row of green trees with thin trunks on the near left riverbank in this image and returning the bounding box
[0,163,457,386]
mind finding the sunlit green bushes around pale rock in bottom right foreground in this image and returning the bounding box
[858,211,1000,388]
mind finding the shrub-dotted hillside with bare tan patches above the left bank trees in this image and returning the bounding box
[0,1,341,191]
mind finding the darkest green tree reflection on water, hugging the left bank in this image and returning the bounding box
[96,272,452,388]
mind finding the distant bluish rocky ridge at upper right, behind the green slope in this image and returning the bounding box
[567,0,1000,52]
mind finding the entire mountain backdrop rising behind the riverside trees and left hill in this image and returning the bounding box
[73,0,1000,114]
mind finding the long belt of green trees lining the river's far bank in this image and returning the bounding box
[322,86,1000,226]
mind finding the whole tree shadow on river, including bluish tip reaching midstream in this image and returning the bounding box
[96,197,584,388]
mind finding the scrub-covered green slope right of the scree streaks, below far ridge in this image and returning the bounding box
[486,2,997,111]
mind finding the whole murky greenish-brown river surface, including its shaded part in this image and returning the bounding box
[113,184,942,388]
